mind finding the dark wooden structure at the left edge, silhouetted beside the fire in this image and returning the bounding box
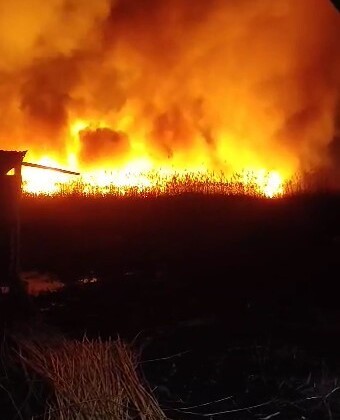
[0,150,26,294]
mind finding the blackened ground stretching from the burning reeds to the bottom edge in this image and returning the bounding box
[12,194,340,420]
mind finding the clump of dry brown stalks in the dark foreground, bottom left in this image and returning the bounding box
[17,338,166,420]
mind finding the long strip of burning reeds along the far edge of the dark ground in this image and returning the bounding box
[23,168,338,198]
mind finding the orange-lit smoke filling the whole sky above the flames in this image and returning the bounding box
[0,0,340,177]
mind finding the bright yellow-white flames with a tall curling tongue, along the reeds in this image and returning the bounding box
[23,120,284,198]
